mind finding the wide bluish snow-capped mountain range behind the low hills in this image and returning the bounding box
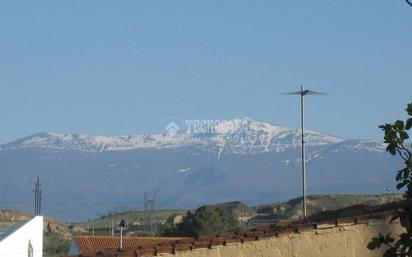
[0,118,400,220]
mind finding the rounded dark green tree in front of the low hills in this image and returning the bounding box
[161,205,238,237]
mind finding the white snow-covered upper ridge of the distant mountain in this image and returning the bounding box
[1,118,350,153]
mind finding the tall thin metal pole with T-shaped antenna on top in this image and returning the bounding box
[283,86,327,218]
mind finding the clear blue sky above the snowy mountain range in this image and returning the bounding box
[0,0,412,143]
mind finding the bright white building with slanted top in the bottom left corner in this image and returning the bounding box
[0,216,43,257]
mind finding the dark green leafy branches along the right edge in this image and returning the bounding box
[368,103,412,257]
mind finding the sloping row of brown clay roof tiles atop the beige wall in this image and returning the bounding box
[68,201,405,257]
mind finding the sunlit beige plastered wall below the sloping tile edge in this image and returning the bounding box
[161,220,403,257]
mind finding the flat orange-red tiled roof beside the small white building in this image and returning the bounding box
[73,236,187,255]
